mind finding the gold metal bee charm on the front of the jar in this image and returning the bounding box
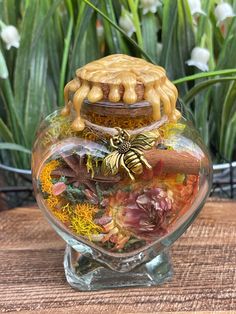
[102,128,159,181]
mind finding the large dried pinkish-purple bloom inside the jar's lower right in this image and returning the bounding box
[112,188,172,239]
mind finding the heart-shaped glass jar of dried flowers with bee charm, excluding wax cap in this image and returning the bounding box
[32,53,211,290]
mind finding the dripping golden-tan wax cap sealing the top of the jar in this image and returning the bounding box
[62,54,180,131]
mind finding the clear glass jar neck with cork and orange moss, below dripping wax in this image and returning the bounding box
[81,100,154,130]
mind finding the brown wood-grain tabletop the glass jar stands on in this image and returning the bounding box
[0,200,236,314]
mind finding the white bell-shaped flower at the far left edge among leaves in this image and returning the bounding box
[0,23,20,50]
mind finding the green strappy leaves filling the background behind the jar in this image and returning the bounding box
[0,0,236,169]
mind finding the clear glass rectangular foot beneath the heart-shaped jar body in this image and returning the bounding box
[64,245,172,291]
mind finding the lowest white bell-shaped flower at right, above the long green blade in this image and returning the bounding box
[186,47,210,72]
